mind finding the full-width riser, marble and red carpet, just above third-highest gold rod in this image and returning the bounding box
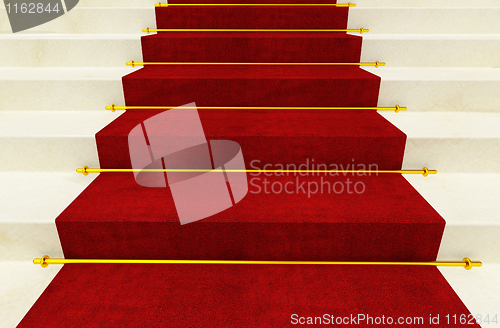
[0,34,500,68]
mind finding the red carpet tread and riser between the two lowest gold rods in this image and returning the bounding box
[56,173,445,261]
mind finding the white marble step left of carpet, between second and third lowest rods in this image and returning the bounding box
[0,111,120,172]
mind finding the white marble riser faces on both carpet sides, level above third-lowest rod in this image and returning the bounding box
[0,72,500,114]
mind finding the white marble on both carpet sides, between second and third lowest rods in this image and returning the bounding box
[0,111,500,173]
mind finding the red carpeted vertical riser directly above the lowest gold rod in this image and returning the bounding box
[56,221,443,261]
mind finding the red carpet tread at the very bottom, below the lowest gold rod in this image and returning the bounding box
[19,264,478,327]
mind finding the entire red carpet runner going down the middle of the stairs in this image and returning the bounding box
[20,1,480,327]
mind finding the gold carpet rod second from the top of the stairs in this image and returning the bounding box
[142,27,370,34]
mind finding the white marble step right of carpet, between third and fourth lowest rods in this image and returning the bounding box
[365,67,500,112]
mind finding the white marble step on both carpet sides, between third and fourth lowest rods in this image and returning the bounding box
[0,67,500,112]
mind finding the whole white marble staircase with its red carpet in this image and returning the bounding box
[0,0,500,327]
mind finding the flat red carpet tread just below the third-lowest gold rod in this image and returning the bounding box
[99,109,404,139]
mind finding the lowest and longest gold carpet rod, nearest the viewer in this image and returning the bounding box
[33,255,483,270]
